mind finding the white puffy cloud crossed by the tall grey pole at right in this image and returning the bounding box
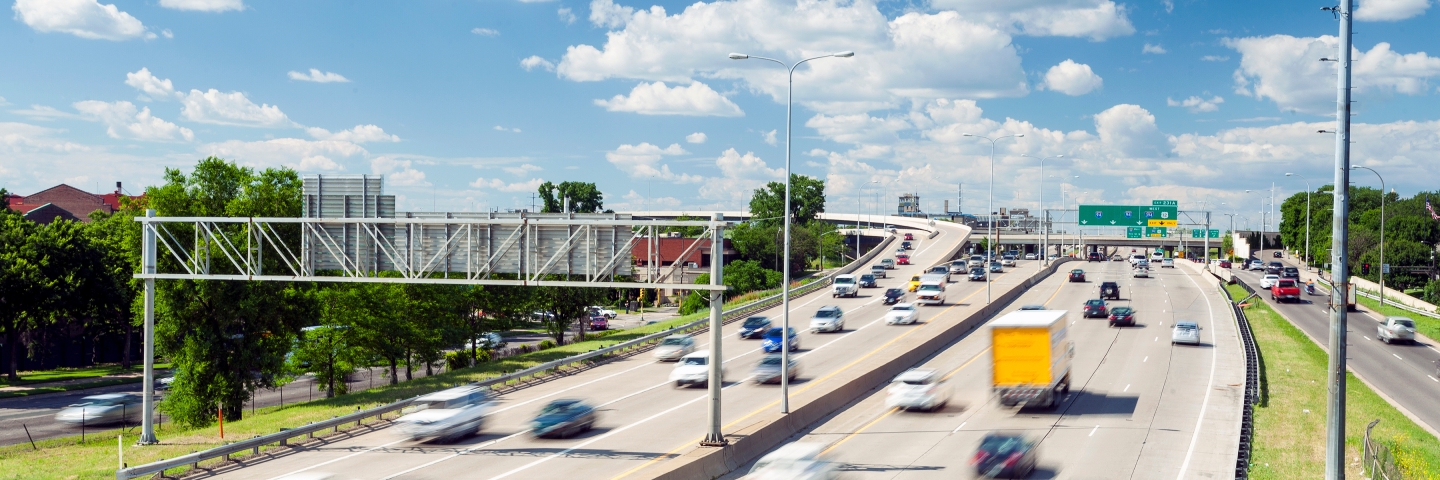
[1224,35,1440,114]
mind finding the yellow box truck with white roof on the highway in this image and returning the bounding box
[991,310,1074,408]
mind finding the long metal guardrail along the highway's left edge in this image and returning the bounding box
[115,235,894,480]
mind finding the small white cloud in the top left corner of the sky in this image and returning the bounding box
[10,0,156,42]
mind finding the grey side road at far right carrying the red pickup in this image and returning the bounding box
[1231,251,1440,435]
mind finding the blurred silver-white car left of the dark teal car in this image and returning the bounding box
[395,385,495,443]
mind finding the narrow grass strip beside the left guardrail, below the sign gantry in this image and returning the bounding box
[0,307,739,479]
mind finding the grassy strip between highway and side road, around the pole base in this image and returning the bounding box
[1228,285,1440,479]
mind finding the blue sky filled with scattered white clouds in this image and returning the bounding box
[0,0,1440,224]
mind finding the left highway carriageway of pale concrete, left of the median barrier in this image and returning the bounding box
[194,221,1013,479]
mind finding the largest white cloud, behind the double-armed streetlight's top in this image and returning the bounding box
[556,0,1028,112]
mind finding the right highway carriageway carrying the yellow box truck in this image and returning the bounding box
[726,253,1244,479]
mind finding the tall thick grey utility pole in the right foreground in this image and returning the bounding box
[1325,0,1354,480]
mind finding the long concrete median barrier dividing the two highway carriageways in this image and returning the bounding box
[642,259,1064,480]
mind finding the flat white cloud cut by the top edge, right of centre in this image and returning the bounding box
[930,0,1135,40]
